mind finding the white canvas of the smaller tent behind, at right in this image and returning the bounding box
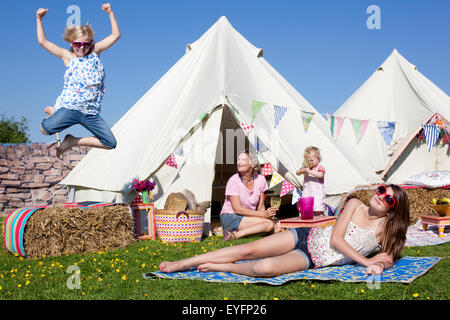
[334,49,450,171]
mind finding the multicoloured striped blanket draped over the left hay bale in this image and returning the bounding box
[3,201,116,257]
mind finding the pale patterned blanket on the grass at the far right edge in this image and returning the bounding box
[405,220,450,247]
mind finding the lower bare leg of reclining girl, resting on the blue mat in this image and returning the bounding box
[198,250,306,277]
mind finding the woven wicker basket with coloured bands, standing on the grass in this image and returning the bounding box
[155,209,205,243]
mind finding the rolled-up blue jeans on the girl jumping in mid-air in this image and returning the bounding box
[41,108,117,149]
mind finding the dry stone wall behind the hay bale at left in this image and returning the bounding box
[0,143,90,215]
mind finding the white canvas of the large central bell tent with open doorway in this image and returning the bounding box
[61,17,380,230]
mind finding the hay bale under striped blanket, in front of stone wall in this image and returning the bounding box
[24,205,135,258]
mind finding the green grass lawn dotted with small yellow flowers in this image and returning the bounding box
[0,222,450,300]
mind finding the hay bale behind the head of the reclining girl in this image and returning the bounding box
[347,188,450,225]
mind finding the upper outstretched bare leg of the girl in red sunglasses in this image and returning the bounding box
[159,232,295,272]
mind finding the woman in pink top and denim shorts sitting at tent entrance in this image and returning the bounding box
[220,150,278,241]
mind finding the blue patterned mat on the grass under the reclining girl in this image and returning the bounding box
[142,256,442,285]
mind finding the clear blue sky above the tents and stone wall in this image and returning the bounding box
[0,0,450,142]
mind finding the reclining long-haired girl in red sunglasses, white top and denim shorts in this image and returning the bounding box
[159,185,409,277]
